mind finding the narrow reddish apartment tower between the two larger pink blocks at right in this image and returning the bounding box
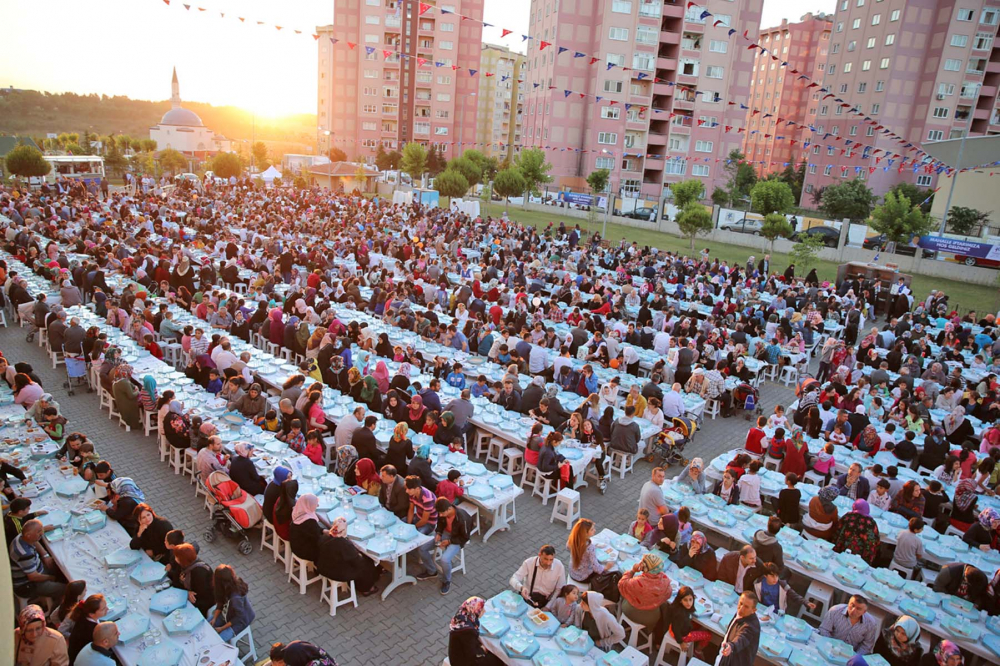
[743,13,833,177]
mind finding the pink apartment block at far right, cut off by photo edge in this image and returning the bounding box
[803,0,1000,202]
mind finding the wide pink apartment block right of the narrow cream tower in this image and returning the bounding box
[521,0,763,198]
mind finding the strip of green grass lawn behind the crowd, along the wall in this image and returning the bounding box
[486,203,1000,312]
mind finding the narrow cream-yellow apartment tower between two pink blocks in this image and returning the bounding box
[476,44,524,161]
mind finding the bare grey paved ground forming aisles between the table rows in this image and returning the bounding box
[0,328,792,666]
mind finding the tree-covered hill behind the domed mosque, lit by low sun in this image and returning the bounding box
[0,90,316,154]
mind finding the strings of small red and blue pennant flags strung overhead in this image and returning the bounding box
[156,0,1000,175]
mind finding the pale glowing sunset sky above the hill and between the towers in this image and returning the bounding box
[0,0,834,116]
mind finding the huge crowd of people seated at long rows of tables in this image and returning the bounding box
[0,172,1000,666]
